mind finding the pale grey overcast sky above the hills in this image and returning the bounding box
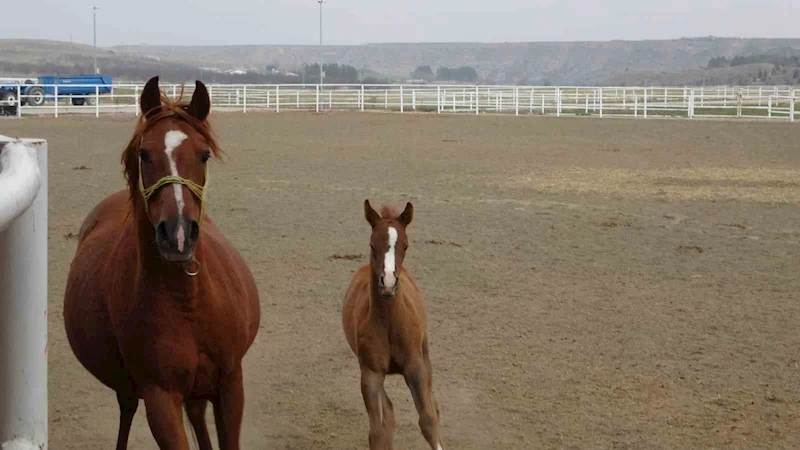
[0,0,800,46]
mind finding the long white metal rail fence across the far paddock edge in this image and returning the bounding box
[3,84,800,121]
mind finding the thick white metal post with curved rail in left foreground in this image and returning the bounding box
[0,136,47,450]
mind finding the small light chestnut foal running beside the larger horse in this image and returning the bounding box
[342,200,442,450]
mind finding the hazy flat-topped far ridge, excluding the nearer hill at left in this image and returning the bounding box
[114,38,800,84]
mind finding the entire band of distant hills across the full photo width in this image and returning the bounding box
[0,37,800,85]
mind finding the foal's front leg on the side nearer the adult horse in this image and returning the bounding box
[361,367,394,450]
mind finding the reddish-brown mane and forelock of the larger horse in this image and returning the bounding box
[122,87,223,196]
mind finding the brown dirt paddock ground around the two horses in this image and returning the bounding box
[0,113,800,450]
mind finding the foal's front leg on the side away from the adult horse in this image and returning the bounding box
[403,352,442,450]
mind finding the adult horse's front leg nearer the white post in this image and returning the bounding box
[142,386,189,450]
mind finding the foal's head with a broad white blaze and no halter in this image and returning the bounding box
[364,200,414,298]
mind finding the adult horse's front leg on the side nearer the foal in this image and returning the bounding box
[214,366,244,450]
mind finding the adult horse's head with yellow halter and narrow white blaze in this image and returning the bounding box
[122,77,220,262]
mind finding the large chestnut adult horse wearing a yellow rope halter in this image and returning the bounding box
[64,77,260,450]
